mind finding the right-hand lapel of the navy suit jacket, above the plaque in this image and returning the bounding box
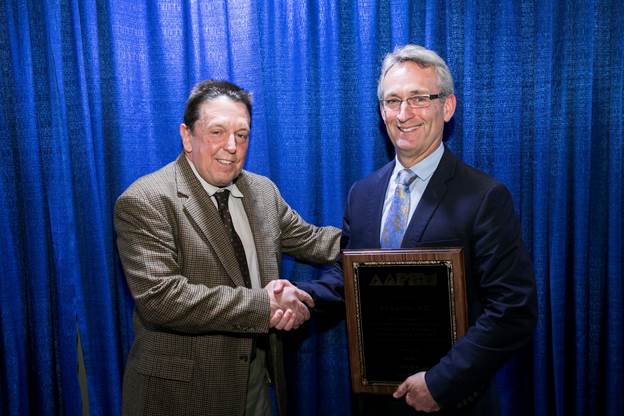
[401,149,457,247]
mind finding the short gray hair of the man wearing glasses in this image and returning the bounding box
[377,45,455,100]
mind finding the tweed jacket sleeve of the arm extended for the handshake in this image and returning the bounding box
[115,186,270,333]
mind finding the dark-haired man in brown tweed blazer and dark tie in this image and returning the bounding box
[115,81,339,415]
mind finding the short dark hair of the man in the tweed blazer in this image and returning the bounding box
[184,79,251,130]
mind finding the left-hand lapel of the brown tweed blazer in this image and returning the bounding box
[176,154,245,286]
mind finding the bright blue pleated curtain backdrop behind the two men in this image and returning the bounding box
[0,0,624,416]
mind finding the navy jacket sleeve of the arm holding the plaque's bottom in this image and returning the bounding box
[425,184,537,407]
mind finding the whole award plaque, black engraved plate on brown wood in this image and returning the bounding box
[343,248,467,394]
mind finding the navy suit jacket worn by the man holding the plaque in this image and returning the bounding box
[298,149,537,408]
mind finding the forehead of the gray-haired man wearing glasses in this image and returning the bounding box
[381,61,438,96]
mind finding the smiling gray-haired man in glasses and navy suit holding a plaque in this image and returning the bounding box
[298,45,537,415]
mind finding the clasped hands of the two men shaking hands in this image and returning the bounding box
[264,279,314,331]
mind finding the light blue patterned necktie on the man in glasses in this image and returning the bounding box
[380,169,417,248]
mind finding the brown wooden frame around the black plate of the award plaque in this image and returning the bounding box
[342,247,468,394]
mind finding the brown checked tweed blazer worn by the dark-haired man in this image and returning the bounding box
[115,154,340,415]
